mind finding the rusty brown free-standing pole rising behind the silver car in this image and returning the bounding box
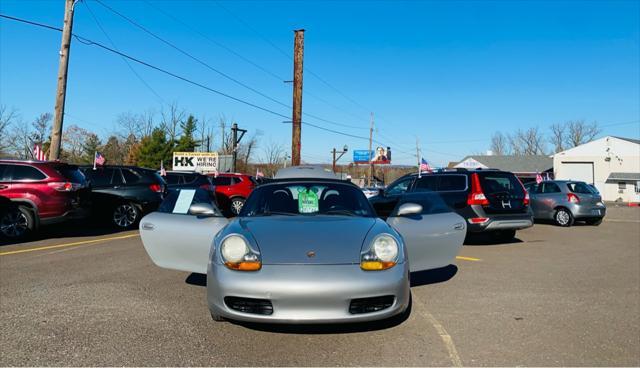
[291,29,304,166]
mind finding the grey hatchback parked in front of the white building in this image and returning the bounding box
[529,180,607,226]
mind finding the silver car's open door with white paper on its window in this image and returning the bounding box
[140,189,229,274]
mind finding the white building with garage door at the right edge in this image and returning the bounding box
[553,136,640,203]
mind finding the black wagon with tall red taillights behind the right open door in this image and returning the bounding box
[369,169,533,241]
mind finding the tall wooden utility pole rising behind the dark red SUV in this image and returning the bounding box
[49,0,76,161]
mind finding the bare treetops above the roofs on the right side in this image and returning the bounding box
[489,120,602,156]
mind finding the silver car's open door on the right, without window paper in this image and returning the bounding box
[387,192,467,272]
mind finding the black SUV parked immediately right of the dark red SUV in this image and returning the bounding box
[81,166,167,228]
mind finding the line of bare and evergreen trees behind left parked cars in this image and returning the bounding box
[0,104,287,174]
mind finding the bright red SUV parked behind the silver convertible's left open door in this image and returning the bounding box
[209,173,257,216]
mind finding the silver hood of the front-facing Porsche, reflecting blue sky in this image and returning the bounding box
[240,215,375,264]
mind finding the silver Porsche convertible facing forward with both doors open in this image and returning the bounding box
[140,172,466,323]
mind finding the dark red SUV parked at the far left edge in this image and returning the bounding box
[0,160,89,239]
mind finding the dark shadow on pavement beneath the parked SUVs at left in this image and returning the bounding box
[0,219,131,246]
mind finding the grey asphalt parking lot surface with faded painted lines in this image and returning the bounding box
[0,208,640,366]
